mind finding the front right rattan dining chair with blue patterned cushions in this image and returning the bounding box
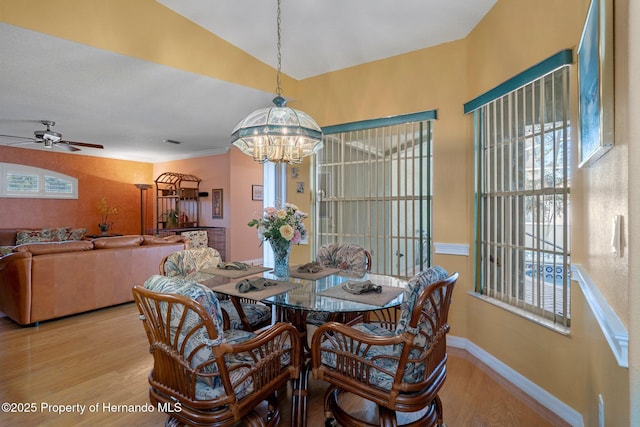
[311,267,458,426]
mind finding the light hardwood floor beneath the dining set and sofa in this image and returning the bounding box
[0,303,566,427]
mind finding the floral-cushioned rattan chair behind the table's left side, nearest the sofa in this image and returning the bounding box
[160,247,271,331]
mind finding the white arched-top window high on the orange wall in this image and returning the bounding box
[0,163,78,199]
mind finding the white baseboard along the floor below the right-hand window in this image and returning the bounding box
[447,335,584,427]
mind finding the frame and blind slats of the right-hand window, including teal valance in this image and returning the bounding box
[464,50,573,333]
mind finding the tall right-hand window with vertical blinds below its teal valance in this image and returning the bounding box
[474,51,571,328]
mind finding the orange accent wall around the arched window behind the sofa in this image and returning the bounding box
[0,146,153,234]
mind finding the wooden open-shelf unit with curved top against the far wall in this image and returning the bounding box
[155,172,200,230]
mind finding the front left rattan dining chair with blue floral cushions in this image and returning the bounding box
[133,275,300,426]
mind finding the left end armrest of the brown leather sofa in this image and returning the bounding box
[0,252,32,325]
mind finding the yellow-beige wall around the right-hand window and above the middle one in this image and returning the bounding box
[292,0,629,426]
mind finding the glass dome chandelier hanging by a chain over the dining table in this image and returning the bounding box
[231,0,322,164]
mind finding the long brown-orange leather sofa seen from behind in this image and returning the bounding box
[0,235,185,325]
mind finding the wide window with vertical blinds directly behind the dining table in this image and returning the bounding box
[315,111,435,277]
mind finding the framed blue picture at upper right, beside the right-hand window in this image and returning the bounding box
[578,0,614,167]
